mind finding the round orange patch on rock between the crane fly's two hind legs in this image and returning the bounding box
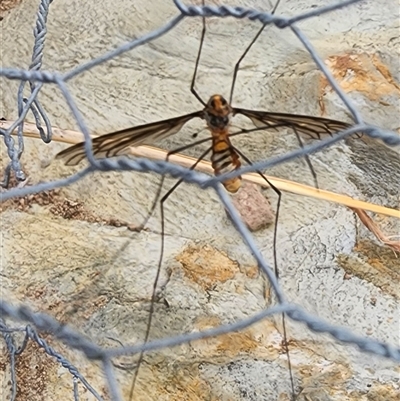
[176,245,239,291]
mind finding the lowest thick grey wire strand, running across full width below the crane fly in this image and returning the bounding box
[0,301,400,362]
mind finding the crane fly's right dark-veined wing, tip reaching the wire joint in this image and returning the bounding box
[233,108,362,139]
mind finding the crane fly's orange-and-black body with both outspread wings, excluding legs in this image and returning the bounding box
[57,95,350,193]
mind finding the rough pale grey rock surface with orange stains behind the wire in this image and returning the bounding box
[0,0,400,401]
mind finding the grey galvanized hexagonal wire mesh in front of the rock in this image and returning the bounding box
[0,0,400,400]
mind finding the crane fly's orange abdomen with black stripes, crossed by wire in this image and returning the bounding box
[211,130,242,193]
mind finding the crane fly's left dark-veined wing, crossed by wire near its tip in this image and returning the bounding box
[56,110,203,166]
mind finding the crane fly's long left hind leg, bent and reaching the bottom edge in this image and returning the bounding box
[129,147,212,401]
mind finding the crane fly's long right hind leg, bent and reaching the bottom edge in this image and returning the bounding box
[234,148,296,401]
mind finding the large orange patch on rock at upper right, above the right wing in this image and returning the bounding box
[321,53,400,100]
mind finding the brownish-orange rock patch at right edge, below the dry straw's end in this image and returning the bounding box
[337,240,400,299]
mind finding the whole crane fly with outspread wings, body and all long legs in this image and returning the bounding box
[56,0,361,400]
